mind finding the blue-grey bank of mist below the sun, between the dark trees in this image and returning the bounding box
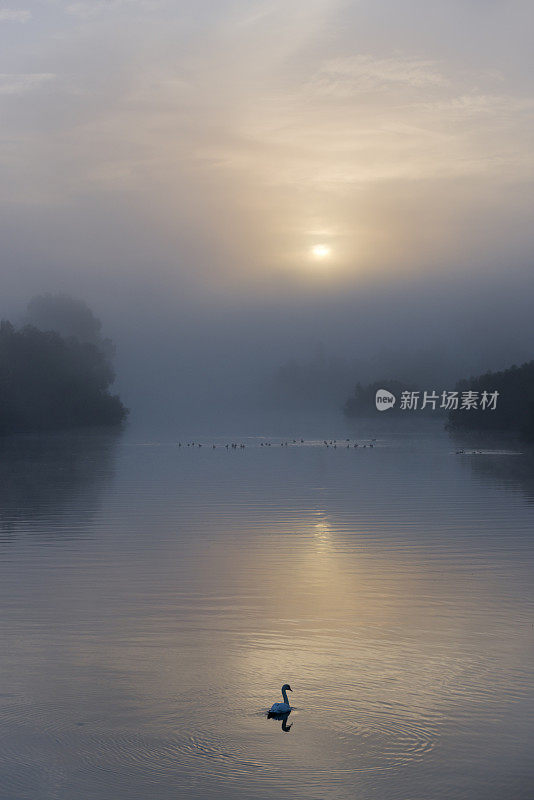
[78,266,534,430]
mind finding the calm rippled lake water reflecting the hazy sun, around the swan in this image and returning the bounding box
[0,421,534,800]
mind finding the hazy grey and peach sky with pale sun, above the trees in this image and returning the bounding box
[0,0,534,428]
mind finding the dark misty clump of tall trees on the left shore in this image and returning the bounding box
[0,295,128,435]
